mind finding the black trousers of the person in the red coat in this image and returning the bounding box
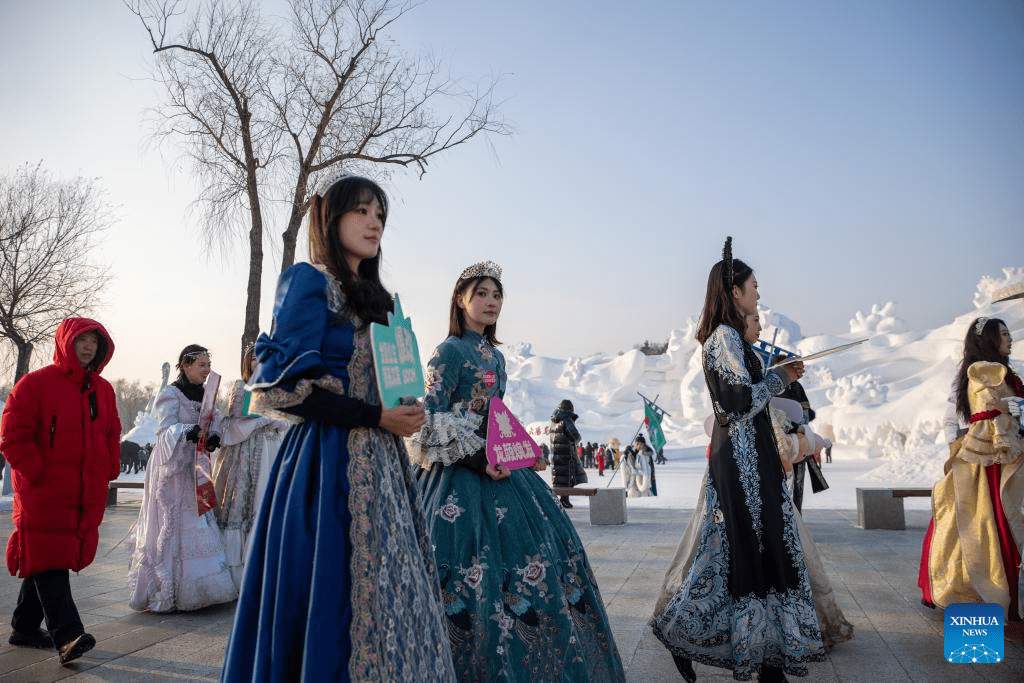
[10,569,85,648]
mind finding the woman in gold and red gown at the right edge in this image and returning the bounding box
[919,317,1024,618]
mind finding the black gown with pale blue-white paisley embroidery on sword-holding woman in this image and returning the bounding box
[650,326,824,680]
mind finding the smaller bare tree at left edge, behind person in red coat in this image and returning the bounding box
[0,163,114,382]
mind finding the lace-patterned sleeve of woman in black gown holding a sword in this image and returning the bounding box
[703,325,785,426]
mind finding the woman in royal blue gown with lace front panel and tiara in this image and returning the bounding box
[221,175,454,683]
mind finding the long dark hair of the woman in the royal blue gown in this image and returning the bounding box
[308,175,393,323]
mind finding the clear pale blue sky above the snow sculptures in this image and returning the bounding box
[0,0,1024,379]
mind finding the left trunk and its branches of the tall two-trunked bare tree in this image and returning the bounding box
[128,0,280,368]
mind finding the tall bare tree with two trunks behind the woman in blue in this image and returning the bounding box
[126,0,509,362]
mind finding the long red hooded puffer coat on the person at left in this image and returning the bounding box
[0,317,121,578]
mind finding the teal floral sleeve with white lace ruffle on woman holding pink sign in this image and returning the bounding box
[407,343,486,467]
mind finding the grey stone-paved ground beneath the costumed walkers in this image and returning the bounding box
[0,493,1024,683]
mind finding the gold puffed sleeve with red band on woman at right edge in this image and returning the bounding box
[957,361,1024,465]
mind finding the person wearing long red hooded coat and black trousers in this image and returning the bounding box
[0,317,121,664]
